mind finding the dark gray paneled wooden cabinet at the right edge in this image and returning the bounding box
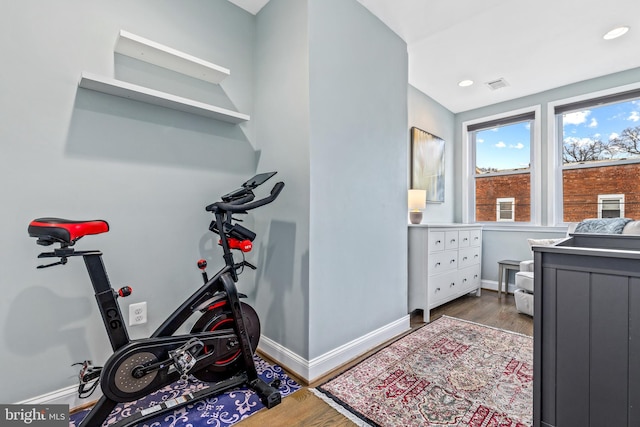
[533,234,640,427]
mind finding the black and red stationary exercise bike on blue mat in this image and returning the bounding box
[28,172,284,427]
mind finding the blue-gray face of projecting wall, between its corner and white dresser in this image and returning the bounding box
[308,0,408,359]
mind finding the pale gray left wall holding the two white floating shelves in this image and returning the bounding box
[0,0,264,403]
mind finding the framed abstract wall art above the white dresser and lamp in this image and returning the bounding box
[411,127,444,203]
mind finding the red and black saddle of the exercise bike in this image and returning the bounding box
[28,218,109,245]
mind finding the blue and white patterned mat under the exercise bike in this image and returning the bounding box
[69,356,300,427]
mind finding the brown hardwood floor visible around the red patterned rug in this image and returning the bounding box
[237,290,533,427]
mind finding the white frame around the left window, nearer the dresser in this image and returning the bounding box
[462,105,542,226]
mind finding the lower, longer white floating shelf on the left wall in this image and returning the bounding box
[78,73,250,123]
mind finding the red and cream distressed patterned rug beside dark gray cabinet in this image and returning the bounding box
[318,316,533,427]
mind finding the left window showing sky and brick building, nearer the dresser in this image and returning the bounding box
[465,109,538,223]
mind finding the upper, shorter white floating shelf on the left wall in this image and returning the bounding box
[115,30,231,84]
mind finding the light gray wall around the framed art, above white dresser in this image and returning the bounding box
[407,85,456,223]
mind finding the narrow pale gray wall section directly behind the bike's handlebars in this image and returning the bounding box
[255,0,311,357]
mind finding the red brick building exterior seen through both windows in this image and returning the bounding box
[476,163,640,222]
